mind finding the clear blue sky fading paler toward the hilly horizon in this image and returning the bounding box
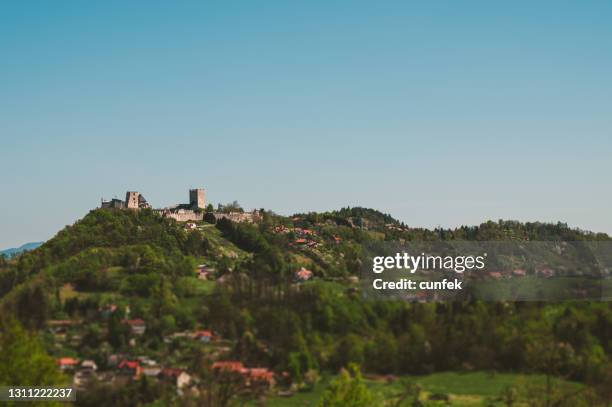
[0,0,612,248]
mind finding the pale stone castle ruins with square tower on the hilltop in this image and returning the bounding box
[100,188,260,223]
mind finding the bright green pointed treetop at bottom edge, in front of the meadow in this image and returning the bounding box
[319,364,380,407]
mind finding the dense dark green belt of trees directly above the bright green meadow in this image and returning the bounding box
[208,283,612,388]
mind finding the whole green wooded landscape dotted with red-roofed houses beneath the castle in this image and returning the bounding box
[0,208,612,407]
